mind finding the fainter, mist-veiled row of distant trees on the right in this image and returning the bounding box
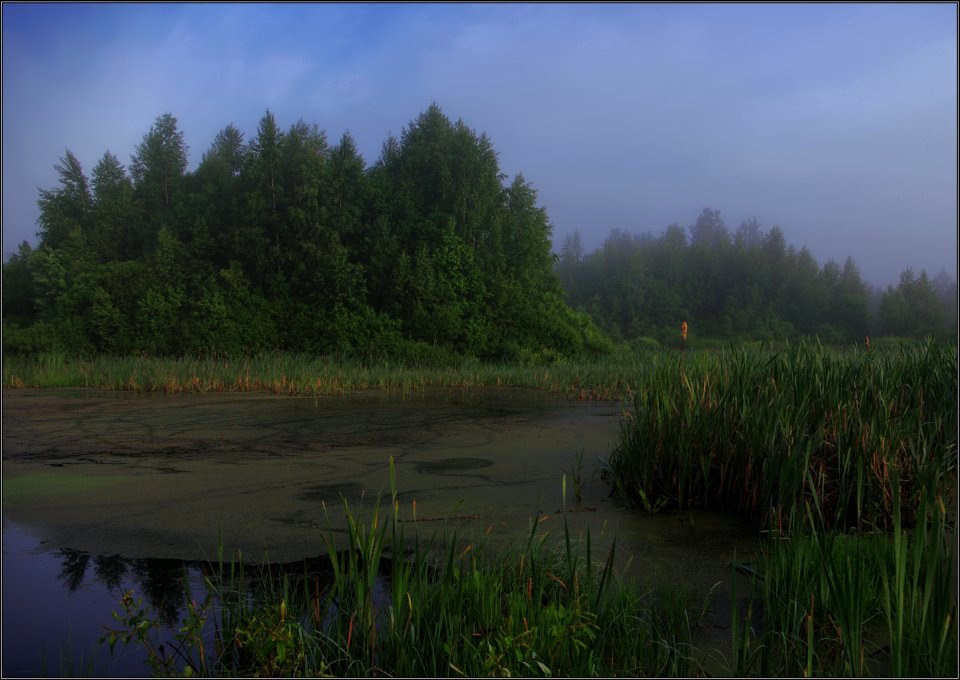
[556,208,957,344]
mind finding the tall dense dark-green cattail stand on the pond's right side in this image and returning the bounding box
[607,340,957,533]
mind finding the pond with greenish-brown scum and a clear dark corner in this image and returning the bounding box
[3,389,756,676]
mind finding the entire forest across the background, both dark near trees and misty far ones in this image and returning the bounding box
[3,104,957,361]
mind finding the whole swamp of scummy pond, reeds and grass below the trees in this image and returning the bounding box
[3,342,957,677]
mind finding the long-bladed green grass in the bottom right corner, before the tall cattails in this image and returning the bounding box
[724,480,958,677]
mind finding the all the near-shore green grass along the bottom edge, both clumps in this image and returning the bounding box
[104,466,957,677]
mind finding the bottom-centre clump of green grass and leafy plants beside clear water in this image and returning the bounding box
[108,461,702,677]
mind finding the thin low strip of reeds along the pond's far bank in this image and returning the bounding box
[3,353,660,400]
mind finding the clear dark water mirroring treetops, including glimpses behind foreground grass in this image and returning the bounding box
[2,519,389,677]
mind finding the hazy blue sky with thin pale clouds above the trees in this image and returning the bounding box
[2,3,958,287]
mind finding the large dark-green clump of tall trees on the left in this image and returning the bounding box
[3,105,609,360]
